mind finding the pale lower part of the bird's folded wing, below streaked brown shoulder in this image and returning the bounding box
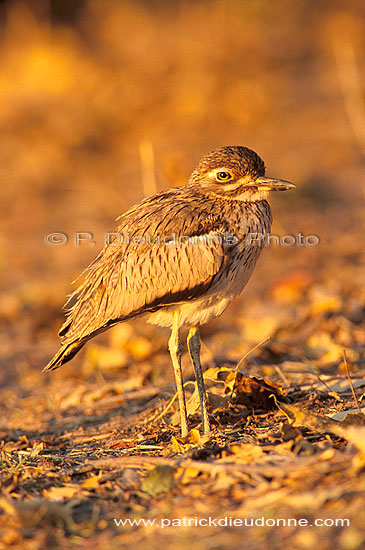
[60,233,227,344]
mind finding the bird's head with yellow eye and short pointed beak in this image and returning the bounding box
[190,145,295,202]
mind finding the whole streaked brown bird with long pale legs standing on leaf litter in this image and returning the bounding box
[43,145,295,438]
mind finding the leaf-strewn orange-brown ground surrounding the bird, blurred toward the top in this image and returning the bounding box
[0,0,365,550]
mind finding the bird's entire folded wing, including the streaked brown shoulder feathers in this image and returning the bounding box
[60,190,232,344]
